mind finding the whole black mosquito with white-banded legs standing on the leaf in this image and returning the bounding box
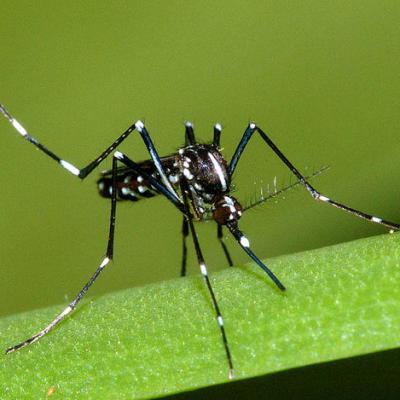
[0,104,400,379]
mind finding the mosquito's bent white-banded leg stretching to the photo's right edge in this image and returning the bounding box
[229,123,400,230]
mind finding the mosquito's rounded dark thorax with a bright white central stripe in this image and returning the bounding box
[179,144,230,203]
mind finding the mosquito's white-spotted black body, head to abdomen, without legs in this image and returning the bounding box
[97,143,241,225]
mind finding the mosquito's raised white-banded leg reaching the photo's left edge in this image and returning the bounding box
[0,104,179,199]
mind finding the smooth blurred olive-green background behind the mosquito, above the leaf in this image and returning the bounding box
[0,0,400,320]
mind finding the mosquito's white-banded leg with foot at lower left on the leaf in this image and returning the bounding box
[6,157,117,354]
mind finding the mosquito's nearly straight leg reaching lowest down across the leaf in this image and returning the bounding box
[182,183,234,379]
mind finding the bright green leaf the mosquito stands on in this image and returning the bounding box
[0,234,400,399]
